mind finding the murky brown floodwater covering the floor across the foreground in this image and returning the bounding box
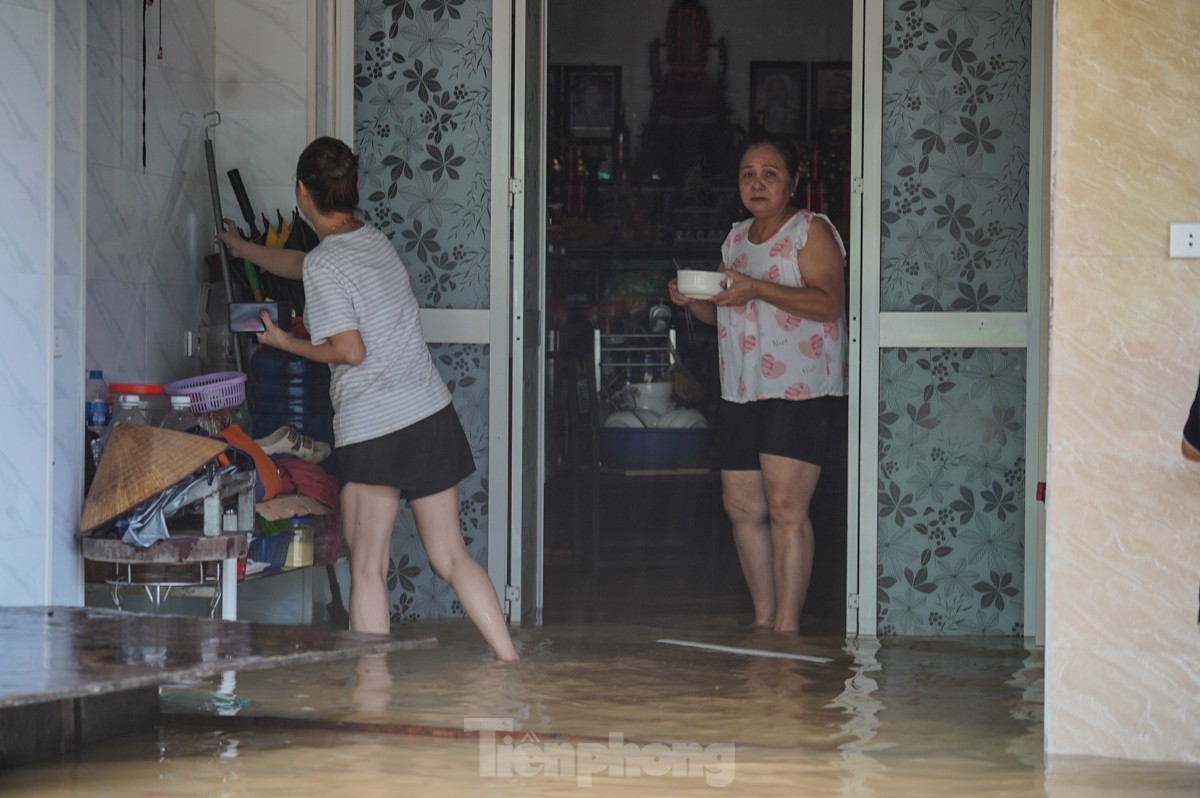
[0,617,1200,798]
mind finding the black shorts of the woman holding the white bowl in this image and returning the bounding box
[716,396,846,472]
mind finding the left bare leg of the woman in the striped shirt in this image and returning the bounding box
[341,482,400,635]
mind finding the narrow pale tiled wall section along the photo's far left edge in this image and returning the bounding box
[0,1,60,604]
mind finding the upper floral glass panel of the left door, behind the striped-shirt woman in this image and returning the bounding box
[354,0,492,308]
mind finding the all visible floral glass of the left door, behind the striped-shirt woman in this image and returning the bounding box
[354,0,492,623]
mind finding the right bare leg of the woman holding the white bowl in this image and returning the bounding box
[758,455,821,631]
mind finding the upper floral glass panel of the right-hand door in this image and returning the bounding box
[880,0,1031,312]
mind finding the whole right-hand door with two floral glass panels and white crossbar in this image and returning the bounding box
[859,0,1042,636]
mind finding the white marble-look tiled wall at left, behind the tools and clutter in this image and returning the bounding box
[0,0,310,605]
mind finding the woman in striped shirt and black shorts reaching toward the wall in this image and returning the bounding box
[221,137,517,660]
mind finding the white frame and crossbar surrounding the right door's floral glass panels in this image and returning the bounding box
[847,0,1049,637]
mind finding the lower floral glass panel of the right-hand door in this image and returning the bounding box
[877,349,1026,637]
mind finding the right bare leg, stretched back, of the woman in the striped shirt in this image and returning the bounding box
[409,486,518,661]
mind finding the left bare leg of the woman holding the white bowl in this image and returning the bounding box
[721,472,776,629]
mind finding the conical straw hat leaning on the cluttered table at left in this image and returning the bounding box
[79,424,228,533]
